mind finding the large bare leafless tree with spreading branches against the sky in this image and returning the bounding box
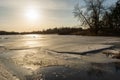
[73,0,105,34]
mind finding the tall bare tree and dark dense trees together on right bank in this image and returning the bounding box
[73,0,120,35]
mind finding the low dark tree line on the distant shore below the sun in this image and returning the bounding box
[0,27,83,35]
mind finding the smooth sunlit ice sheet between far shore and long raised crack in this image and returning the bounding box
[0,35,120,52]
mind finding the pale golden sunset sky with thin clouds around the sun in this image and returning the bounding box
[0,0,116,32]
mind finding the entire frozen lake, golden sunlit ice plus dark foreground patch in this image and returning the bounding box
[0,34,120,80]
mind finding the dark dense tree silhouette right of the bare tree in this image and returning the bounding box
[102,0,120,35]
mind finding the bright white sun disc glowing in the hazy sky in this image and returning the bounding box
[25,8,40,21]
